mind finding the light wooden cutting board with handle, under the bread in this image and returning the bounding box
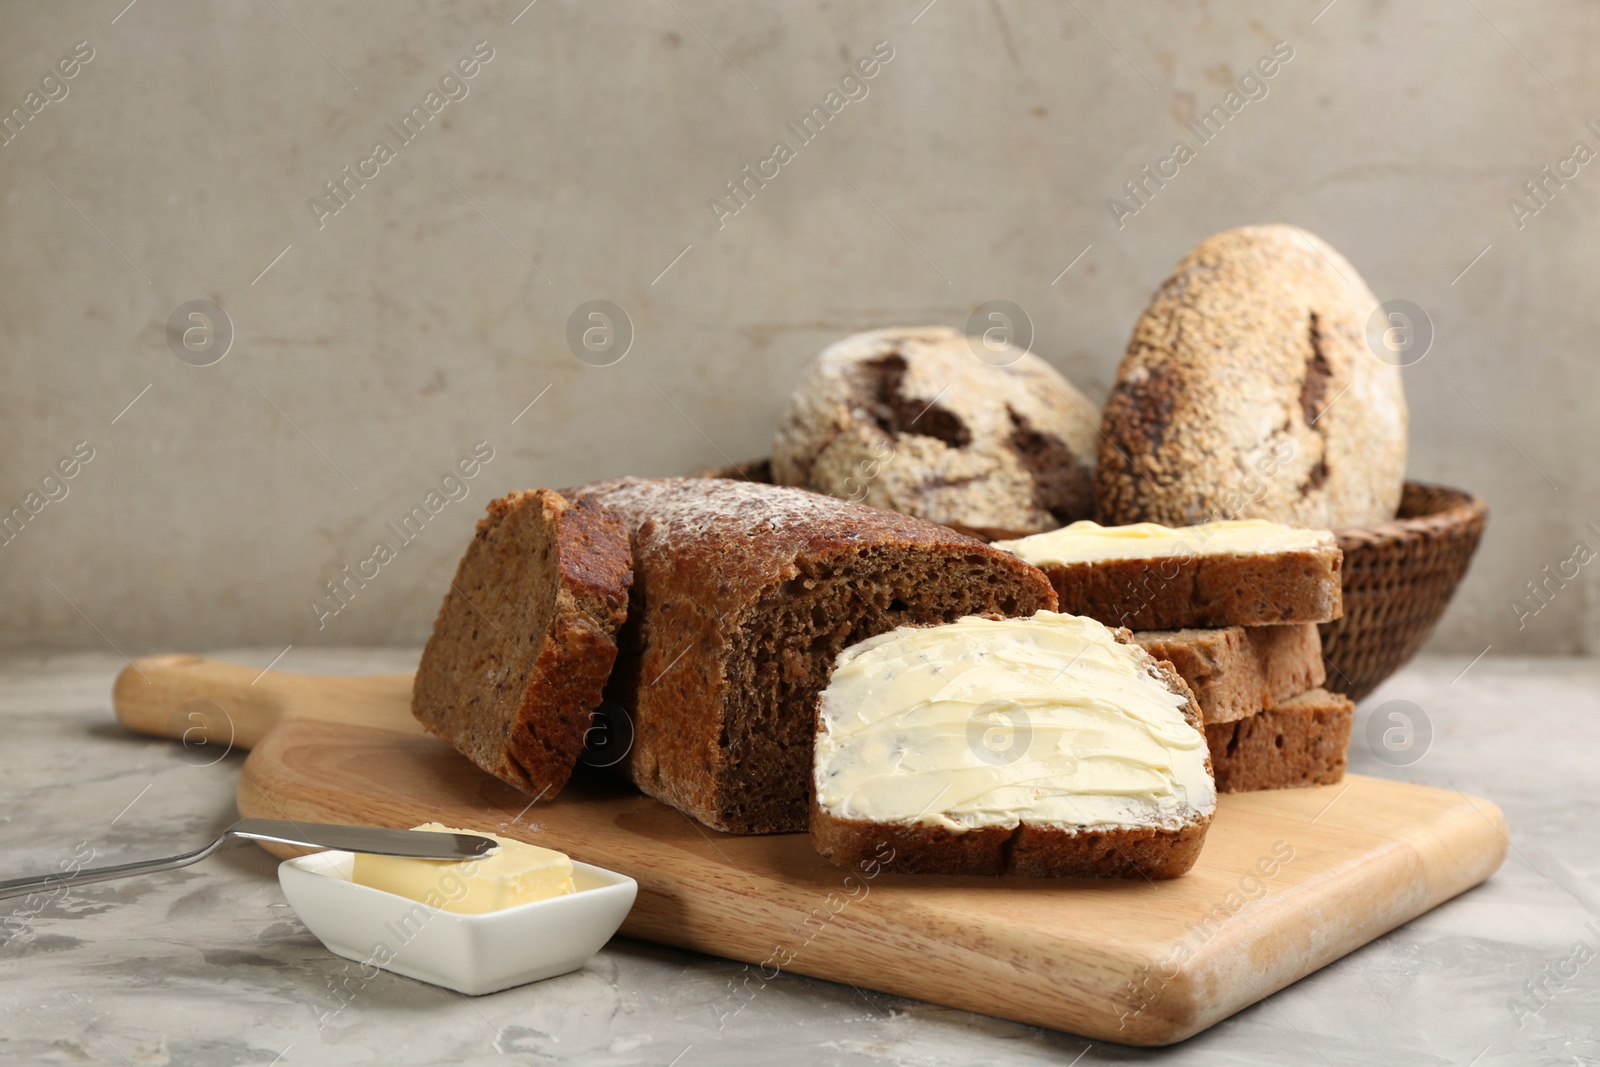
[115,656,1509,1045]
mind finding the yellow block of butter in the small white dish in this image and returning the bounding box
[352,822,573,915]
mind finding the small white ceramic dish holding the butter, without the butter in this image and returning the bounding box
[278,851,638,997]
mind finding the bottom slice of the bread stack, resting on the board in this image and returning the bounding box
[1205,689,1355,793]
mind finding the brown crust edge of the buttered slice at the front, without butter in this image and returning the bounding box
[811,629,1214,878]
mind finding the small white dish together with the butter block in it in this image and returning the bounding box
[278,824,638,997]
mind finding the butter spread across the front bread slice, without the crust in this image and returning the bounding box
[814,611,1216,832]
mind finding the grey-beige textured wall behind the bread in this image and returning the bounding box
[0,0,1600,654]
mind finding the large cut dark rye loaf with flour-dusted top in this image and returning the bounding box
[568,478,1056,833]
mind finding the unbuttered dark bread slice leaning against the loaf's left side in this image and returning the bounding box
[411,490,632,798]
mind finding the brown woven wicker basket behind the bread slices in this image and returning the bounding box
[702,459,1490,701]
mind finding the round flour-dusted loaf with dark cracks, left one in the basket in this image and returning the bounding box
[773,326,1096,537]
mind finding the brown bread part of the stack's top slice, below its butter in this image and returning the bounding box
[1042,547,1344,630]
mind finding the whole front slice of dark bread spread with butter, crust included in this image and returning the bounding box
[811,611,1216,878]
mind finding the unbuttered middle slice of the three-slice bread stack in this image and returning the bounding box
[1133,622,1328,726]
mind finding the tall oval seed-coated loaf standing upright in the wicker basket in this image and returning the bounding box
[1094,226,1406,530]
